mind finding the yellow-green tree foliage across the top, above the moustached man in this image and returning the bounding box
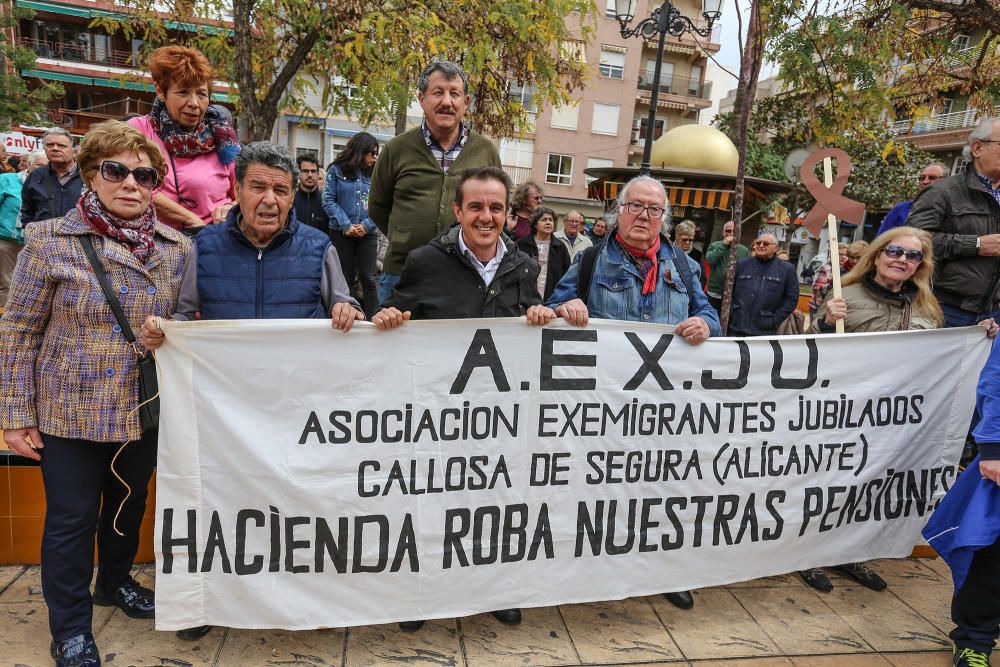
[94,0,596,138]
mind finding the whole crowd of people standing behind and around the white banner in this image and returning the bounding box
[0,46,1000,667]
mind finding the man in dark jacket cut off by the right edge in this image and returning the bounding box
[906,117,1000,327]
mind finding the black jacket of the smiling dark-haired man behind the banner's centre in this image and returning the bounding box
[383,225,542,320]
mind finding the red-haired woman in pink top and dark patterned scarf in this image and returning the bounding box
[128,46,240,232]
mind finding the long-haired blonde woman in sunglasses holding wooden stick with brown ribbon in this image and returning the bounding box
[799,227,997,593]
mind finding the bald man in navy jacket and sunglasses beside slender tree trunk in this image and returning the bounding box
[726,234,799,336]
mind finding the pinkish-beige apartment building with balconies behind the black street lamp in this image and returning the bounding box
[500,0,720,219]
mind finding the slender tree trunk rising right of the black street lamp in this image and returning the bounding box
[720,0,764,335]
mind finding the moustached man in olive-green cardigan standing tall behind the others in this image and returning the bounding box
[368,61,500,303]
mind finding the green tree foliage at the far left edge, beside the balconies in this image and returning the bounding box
[0,6,63,130]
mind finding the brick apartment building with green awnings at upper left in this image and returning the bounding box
[14,0,229,136]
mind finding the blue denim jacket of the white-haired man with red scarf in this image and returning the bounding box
[546,236,721,336]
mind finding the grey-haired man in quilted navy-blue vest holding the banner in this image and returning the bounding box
[140,141,364,640]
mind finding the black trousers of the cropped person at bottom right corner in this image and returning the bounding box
[951,542,1000,653]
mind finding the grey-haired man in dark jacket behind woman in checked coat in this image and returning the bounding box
[21,127,83,225]
